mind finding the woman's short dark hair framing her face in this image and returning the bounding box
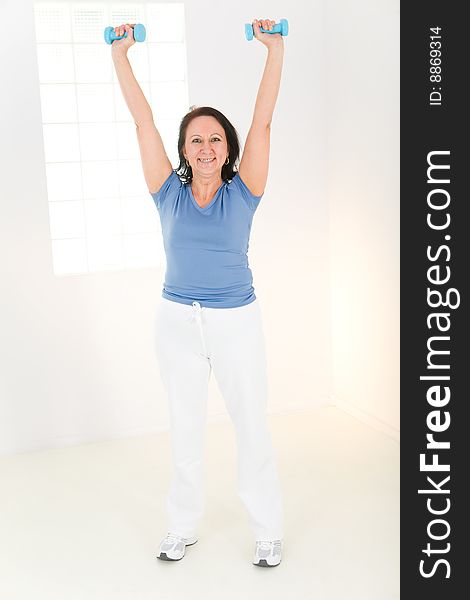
[176,106,240,183]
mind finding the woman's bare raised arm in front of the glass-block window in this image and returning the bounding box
[111,25,172,192]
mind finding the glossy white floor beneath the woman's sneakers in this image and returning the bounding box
[0,407,399,600]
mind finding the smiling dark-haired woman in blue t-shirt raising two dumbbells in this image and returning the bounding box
[112,20,284,566]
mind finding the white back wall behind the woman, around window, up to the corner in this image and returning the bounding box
[0,0,330,454]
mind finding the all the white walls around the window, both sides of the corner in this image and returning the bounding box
[0,0,399,454]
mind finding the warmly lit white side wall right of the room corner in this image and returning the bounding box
[325,0,400,437]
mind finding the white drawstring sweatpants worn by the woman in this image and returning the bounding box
[155,297,283,540]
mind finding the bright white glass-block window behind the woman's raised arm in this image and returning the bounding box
[34,2,188,275]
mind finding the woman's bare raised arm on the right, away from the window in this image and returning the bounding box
[238,20,284,196]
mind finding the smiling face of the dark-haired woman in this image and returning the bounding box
[183,116,228,177]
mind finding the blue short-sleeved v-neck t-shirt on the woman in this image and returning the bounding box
[151,171,263,308]
